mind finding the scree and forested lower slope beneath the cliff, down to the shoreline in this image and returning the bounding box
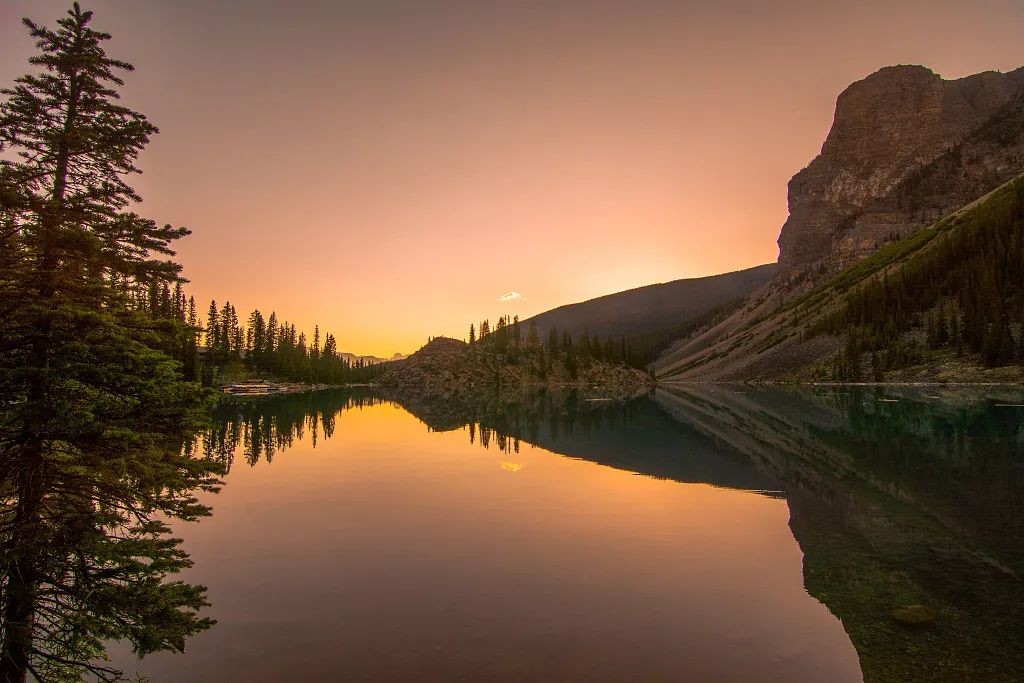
[654,176,1024,382]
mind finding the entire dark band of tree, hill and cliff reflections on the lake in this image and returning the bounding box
[44,387,1024,681]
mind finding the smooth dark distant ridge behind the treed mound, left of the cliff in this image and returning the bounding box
[523,263,775,339]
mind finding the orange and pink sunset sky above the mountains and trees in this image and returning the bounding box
[0,0,1024,355]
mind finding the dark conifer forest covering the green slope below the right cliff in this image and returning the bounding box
[815,179,1024,380]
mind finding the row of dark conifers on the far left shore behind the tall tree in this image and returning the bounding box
[124,282,385,386]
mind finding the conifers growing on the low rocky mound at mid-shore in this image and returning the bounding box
[469,315,645,377]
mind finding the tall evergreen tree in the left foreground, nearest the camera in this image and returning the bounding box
[0,3,216,682]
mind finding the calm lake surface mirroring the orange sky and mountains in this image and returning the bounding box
[116,387,1024,682]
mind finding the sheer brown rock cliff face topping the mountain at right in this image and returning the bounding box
[778,67,1024,281]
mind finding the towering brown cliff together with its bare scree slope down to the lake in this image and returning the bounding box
[655,66,1024,380]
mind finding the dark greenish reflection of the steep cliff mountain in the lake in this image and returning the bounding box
[656,387,1024,681]
